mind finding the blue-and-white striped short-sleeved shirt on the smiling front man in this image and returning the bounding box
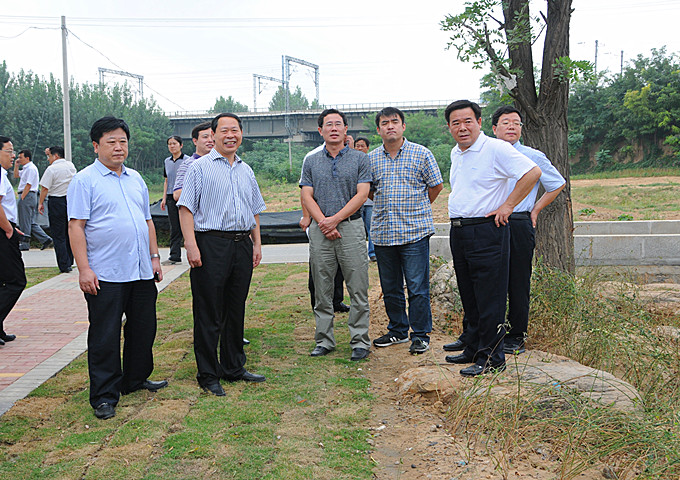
[177,148,266,232]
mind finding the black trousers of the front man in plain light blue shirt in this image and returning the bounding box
[85,280,158,408]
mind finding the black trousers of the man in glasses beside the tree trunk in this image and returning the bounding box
[507,216,536,343]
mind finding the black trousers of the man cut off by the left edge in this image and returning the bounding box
[0,226,26,334]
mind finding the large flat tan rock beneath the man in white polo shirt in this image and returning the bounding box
[397,350,642,412]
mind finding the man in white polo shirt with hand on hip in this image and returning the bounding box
[444,100,541,376]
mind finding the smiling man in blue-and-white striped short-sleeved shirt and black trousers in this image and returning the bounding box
[177,113,265,396]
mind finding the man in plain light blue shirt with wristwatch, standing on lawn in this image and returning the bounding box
[67,117,168,420]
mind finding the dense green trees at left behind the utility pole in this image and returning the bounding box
[0,62,172,174]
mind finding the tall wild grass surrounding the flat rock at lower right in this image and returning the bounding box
[450,261,680,479]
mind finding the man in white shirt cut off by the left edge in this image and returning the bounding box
[0,135,26,345]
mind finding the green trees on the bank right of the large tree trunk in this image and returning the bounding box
[569,47,680,170]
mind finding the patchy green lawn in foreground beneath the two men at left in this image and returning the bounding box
[0,264,372,480]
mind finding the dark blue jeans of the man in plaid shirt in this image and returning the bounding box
[375,237,432,342]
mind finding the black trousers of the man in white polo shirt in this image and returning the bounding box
[449,222,510,366]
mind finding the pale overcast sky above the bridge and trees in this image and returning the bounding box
[0,0,680,113]
